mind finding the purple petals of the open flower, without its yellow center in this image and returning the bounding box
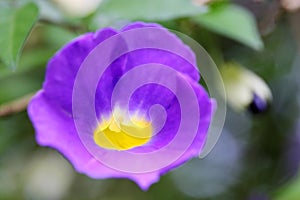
[28,22,214,189]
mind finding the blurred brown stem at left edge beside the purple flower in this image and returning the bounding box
[0,93,34,118]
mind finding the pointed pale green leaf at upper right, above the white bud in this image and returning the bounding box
[193,4,263,50]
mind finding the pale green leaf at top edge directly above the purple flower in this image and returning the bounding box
[97,0,204,27]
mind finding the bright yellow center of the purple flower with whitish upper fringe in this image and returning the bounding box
[94,109,152,150]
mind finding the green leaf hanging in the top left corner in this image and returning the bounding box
[0,3,38,69]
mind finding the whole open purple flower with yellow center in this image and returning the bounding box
[28,22,215,190]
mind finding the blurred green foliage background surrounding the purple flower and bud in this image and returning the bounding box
[0,0,300,200]
